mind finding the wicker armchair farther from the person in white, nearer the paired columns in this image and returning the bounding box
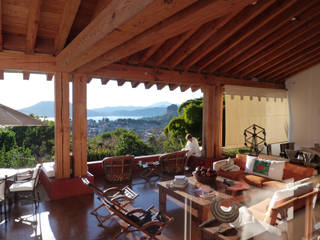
[102,155,134,182]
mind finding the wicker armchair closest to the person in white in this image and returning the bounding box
[159,151,188,174]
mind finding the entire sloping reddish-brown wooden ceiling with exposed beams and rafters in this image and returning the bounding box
[0,0,320,91]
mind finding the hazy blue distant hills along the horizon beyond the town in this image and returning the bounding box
[19,101,175,117]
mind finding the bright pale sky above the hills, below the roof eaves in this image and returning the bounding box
[0,72,202,109]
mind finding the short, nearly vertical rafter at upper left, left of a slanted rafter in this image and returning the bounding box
[26,0,42,53]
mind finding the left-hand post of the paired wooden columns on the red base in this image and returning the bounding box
[54,72,71,178]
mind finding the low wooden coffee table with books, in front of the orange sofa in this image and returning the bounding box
[158,177,242,223]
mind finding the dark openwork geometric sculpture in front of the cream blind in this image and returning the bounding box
[243,124,267,155]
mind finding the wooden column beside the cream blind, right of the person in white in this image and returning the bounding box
[202,85,223,158]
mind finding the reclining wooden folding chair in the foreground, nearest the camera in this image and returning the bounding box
[82,178,173,239]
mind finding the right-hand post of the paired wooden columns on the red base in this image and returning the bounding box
[72,75,88,177]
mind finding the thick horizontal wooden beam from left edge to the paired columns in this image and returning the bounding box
[0,51,56,73]
